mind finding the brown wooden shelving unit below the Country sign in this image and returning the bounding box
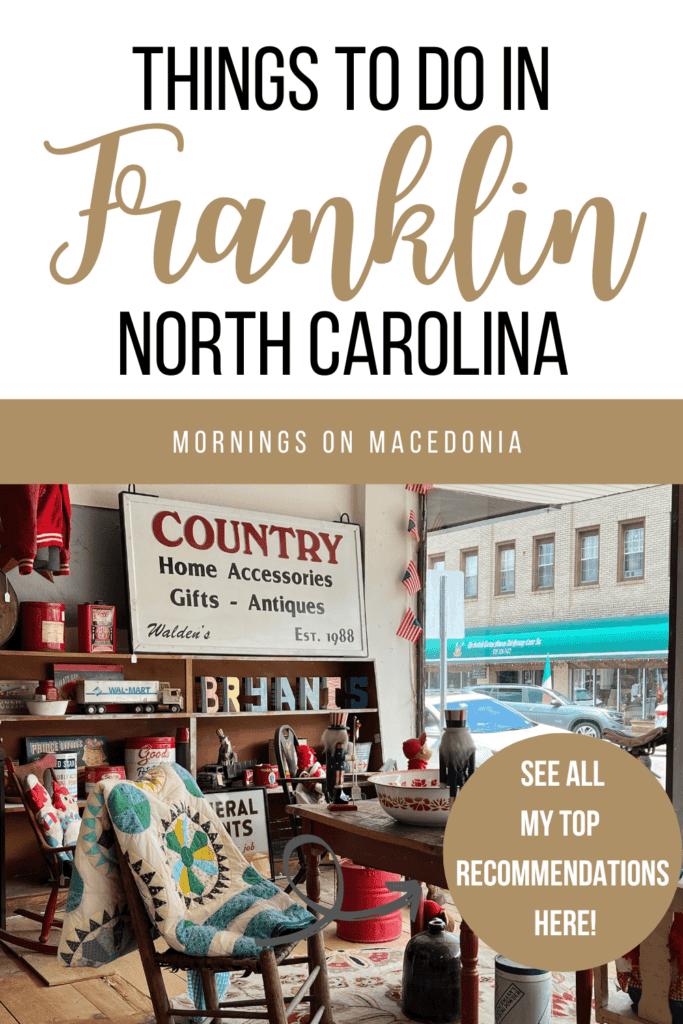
[0,650,384,878]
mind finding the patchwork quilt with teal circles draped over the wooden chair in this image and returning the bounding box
[57,764,314,967]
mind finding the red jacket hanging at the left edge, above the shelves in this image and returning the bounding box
[0,483,71,582]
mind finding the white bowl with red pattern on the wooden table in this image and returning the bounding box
[368,768,451,828]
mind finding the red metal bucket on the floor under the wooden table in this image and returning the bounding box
[337,860,402,942]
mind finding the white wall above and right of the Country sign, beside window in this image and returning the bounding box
[69,483,413,768]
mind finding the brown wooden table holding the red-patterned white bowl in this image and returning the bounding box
[287,800,593,1024]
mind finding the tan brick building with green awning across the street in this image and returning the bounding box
[427,485,671,718]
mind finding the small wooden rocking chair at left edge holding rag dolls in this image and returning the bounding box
[0,754,76,956]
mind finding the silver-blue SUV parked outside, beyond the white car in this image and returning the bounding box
[462,683,624,739]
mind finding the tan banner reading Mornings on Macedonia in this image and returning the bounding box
[1,399,683,483]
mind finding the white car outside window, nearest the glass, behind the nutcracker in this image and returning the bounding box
[425,690,564,767]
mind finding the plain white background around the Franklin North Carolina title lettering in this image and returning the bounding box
[1,0,681,399]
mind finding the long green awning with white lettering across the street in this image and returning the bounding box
[426,615,669,665]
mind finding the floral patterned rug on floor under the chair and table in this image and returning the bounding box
[201,946,577,1024]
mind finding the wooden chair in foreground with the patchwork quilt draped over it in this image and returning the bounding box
[116,839,333,1024]
